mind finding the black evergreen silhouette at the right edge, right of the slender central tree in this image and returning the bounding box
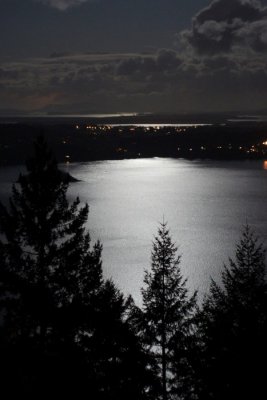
[200,226,267,400]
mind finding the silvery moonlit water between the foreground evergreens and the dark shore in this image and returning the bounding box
[0,158,267,304]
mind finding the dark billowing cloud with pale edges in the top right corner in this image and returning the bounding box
[180,0,267,55]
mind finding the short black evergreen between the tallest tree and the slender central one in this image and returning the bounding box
[82,281,157,400]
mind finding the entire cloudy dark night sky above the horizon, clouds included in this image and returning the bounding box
[0,0,267,114]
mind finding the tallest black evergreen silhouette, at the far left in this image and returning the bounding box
[0,137,103,395]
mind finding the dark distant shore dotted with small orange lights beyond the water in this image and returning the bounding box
[0,119,267,166]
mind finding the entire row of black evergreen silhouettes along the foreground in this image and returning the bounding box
[0,137,267,400]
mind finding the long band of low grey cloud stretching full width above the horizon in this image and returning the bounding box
[0,40,267,112]
